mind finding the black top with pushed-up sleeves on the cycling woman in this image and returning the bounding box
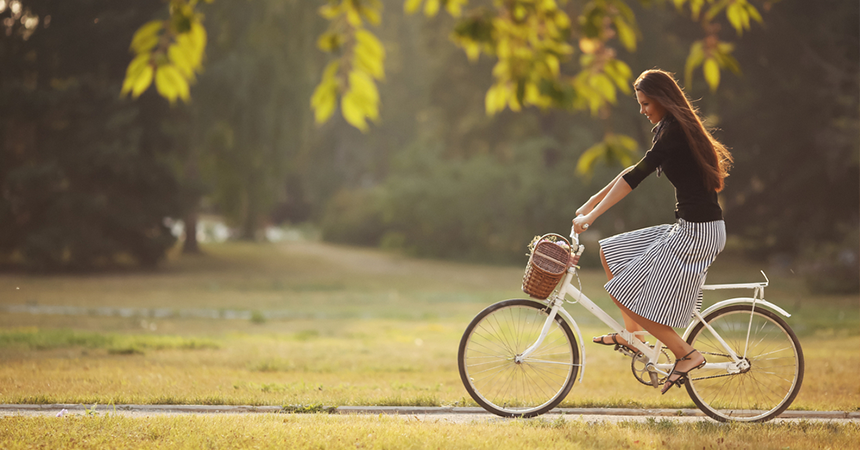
[624,116,723,222]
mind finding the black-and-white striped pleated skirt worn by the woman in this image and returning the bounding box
[600,219,726,328]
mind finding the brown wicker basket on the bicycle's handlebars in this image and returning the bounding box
[523,233,571,300]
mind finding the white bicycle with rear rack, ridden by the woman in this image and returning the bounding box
[457,230,804,422]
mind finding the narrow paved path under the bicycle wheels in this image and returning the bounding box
[0,404,860,424]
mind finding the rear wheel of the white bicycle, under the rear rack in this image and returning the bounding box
[686,305,804,422]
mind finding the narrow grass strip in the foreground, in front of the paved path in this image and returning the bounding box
[0,413,860,450]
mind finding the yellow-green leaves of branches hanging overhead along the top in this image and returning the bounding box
[123,0,779,169]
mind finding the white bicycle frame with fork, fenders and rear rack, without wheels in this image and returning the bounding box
[516,230,791,387]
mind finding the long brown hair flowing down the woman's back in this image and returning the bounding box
[633,69,733,192]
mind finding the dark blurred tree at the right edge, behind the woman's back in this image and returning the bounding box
[715,0,860,292]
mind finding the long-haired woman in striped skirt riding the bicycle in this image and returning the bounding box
[573,70,732,394]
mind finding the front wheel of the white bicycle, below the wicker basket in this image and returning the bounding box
[457,299,580,418]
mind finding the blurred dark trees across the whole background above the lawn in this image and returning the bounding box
[0,0,860,290]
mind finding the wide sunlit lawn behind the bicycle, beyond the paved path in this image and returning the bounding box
[0,242,860,412]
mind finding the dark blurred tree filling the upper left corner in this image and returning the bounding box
[0,0,190,270]
